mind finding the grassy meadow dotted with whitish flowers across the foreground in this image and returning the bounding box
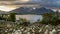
[0,23,60,34]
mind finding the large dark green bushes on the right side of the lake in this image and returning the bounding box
[41,12,60,26]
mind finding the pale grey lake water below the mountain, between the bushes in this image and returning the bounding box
[16,15,42,22]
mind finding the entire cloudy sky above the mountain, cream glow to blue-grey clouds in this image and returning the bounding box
[0,0,60,11]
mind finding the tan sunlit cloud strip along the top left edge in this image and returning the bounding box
[0,0,29,5]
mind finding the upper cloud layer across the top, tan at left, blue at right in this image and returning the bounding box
[0,0,60,8]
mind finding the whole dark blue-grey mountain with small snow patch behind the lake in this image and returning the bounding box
[9,7,53,15]
